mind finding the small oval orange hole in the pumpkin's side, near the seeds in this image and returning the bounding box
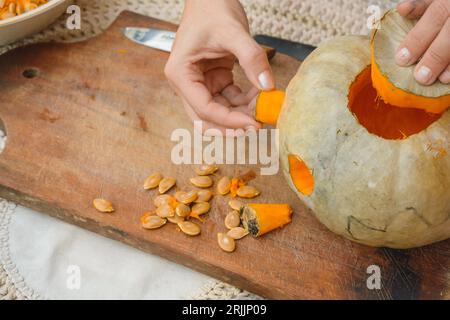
[288,154,314,196]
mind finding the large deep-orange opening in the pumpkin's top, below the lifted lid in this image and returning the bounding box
[348,66,442,140]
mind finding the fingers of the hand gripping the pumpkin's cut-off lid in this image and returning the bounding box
[396,0,450,85]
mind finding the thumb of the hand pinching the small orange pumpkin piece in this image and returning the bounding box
[225,31,275,90]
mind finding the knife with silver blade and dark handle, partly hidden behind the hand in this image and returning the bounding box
[122,27,315,60]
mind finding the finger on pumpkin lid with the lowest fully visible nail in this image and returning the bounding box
[414,19,450,85]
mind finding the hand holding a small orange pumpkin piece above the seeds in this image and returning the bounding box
[165,0,275,132]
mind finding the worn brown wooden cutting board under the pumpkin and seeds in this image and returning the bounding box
[0,12,450,299]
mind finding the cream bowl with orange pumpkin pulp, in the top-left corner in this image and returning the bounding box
[0,0,68,45]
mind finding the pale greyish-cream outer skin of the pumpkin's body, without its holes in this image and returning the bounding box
[277,36,450,248]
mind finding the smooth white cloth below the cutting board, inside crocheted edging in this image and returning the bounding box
[9,206,213,299]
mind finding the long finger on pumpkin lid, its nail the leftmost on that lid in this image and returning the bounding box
[395,0,450,66]
